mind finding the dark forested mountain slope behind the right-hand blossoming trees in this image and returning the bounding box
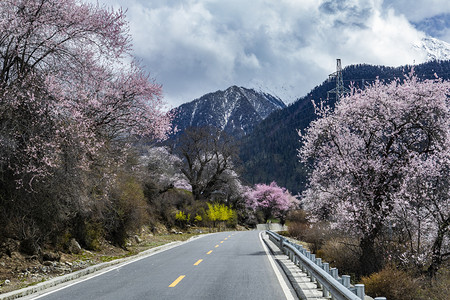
[240,60,450,193]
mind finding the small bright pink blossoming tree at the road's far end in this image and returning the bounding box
[244,181,298,224]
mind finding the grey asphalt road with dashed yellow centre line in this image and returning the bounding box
[23,231,293,300]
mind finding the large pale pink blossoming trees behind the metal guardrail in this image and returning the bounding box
[299,73,450,276]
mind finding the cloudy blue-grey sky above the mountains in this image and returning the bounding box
[89,0,450,107]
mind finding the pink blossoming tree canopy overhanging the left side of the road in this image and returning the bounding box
[0,0,173,187]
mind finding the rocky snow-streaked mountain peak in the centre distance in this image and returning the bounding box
[173,86,286,137]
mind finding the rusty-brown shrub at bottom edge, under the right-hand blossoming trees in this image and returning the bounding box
[361,265,420,300]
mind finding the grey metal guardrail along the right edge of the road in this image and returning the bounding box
[266,230,386,300]
